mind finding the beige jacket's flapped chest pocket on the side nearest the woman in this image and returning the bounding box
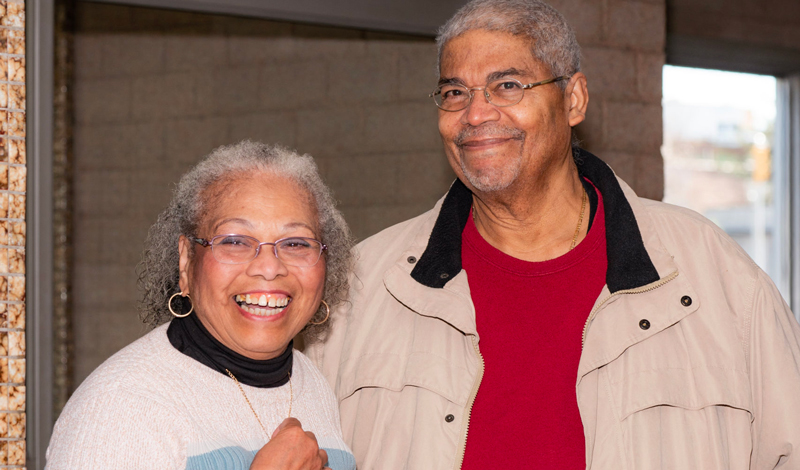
[336,335,477,469]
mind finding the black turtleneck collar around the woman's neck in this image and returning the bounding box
[167,314,292,388]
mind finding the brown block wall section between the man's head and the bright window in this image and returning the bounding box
[552,0,666,199]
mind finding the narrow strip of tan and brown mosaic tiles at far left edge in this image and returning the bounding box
[0,0,27,469]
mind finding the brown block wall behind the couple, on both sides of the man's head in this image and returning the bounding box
[73,0,664,386]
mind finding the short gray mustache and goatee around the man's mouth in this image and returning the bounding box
[455,125,525,193]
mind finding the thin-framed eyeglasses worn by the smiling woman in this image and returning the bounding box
[190,234,328,267]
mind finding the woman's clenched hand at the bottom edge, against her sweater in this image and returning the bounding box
[250,418,328,470]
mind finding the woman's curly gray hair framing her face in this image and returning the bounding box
[137,140,353,340]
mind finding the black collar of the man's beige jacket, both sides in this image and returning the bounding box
[411,149,659,293]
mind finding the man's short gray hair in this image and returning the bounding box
[436,0,581,89]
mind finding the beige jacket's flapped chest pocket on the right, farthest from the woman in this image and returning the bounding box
[598,324,753,469]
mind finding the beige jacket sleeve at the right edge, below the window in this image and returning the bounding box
[745,270,800,470]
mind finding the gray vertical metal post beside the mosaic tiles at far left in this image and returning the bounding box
[25,0,55,470]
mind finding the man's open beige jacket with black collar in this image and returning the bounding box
[309,152,800,470]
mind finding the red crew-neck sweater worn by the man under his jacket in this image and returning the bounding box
[461,188,607,470]
